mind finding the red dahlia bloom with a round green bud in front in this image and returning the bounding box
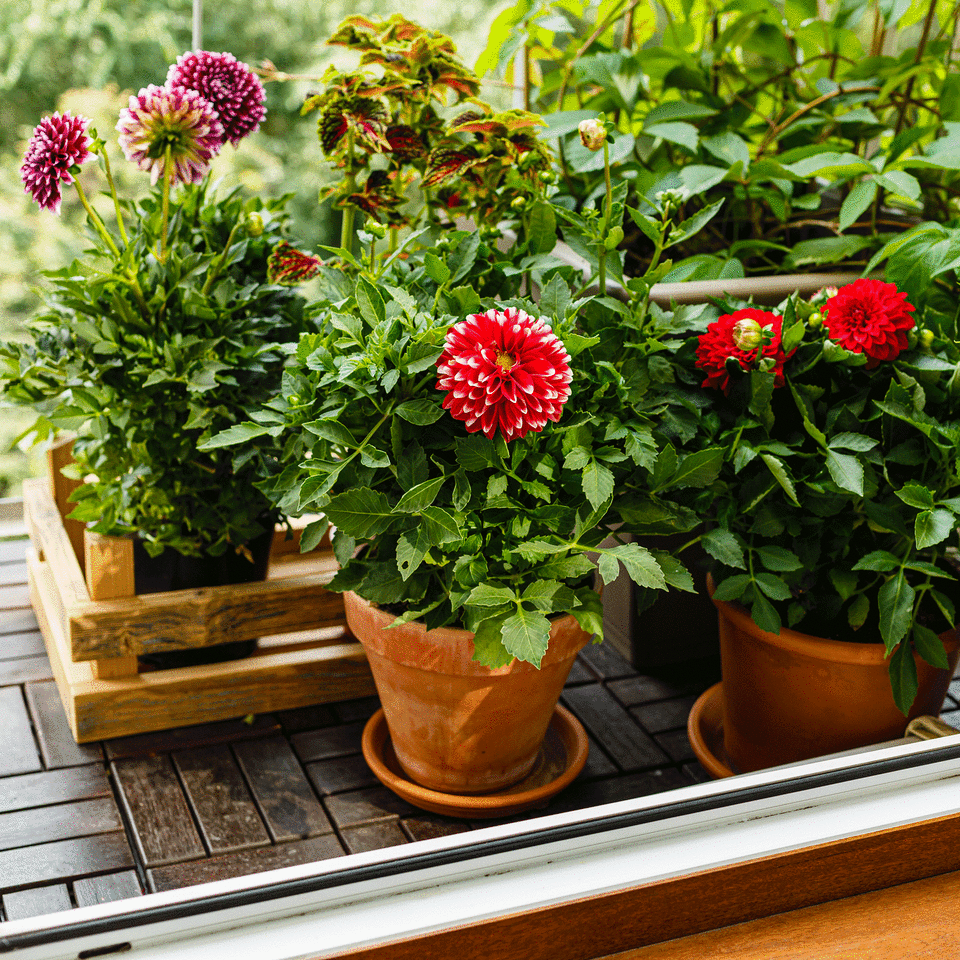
[697,307,787,393]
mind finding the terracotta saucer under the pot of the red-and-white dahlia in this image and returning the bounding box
[363,704,589,819]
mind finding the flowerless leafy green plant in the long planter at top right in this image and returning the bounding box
[480,0,960,284]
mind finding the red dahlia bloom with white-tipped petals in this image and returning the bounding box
[437,307,573,441]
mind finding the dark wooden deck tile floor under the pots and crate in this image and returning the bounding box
[0,539,960,920]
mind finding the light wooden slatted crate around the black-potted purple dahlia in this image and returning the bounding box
[24,451,375,743]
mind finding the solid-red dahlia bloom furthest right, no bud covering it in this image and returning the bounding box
[823,279,914,366]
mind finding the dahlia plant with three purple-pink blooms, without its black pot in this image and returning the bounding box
[0,51,304,555]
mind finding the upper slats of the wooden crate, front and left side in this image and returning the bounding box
[24,481,344,661]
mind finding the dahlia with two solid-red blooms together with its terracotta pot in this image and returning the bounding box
[677,266,960,771]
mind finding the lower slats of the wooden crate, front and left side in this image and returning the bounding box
[28,551,375,743]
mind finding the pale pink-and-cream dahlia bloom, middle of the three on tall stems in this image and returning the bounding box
[117,84,223,183]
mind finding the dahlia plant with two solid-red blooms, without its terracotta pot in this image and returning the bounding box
[664,279,960,712]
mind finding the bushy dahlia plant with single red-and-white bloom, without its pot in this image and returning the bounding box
[205,246,716,667]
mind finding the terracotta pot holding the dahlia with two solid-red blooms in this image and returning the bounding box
[711,585,960,773]
